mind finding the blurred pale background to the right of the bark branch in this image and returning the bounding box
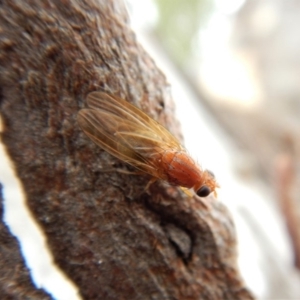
[126,0,300,299]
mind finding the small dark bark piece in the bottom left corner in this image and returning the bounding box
[0,184,51,300]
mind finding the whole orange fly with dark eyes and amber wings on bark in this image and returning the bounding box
[77,92,218,197]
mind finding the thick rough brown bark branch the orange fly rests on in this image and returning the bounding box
[0,0,253,300]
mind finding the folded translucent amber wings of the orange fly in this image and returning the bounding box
[77,92,183,177]
